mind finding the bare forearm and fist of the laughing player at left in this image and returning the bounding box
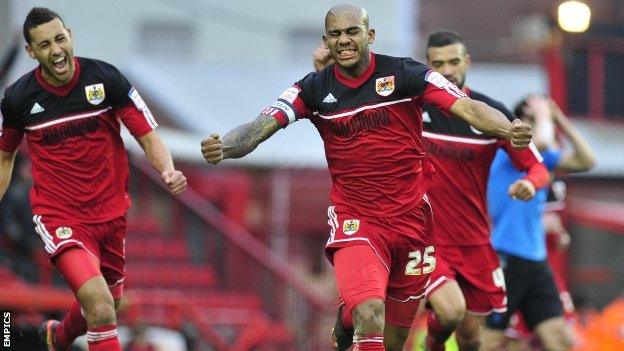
[137,131,187,195]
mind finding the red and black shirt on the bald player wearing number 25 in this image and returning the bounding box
[263,54,465,217]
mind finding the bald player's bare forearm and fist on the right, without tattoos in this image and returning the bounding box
[451,97,531,149]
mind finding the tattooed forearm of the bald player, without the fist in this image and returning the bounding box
[223,115,280,158]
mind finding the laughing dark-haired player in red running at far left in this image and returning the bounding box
[0,7,186,351]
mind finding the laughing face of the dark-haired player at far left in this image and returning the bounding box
[26,18,74,86]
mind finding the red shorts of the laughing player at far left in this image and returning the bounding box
[33,215,126,299]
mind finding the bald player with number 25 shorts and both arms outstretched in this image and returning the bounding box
[201,5,531,350]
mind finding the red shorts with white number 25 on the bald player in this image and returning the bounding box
[325,200,437,328]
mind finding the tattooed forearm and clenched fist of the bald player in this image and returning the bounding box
[201,114,282,165]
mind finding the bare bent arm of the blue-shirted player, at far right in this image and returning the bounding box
[551,102,596,172]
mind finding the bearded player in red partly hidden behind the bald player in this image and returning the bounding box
[423,31,549,351]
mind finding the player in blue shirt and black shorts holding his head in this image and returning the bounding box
[483,95,595,350]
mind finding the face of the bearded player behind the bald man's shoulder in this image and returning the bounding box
[427,43,470,89]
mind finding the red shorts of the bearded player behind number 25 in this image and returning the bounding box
[426,244,507,315]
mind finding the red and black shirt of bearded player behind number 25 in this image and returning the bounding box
[423,89,547,246]
